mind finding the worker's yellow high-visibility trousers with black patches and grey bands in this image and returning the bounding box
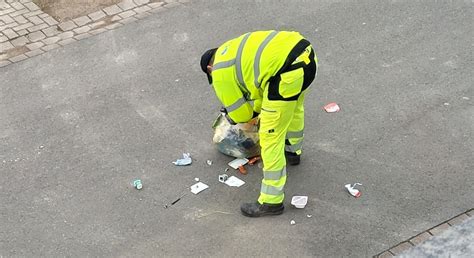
[258,46,317,204]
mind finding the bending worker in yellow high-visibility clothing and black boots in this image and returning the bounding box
[201,30,318,217]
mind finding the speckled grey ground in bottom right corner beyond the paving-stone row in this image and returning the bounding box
[400,218,474,258]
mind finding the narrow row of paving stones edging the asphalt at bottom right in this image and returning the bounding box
[374,208,474,258]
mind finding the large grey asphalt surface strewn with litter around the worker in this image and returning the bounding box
[0,0,474,257]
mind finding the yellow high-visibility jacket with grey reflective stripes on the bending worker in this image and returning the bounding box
[212,31,309,123]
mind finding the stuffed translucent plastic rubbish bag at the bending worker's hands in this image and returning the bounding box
[212,113,260,158]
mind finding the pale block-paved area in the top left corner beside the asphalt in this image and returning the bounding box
[0,0,190,67]
